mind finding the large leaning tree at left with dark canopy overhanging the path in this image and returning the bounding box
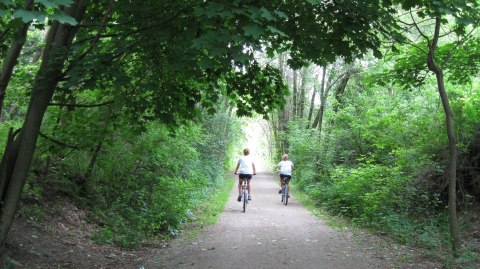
[0,0,400,253]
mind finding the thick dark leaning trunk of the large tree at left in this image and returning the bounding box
[0,0,86,249]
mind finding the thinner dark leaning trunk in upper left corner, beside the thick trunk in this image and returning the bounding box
[0,0,33,121]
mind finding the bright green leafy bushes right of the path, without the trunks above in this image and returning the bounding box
[286,57,480,252]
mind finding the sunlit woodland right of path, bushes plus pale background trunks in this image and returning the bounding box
[269,52,480,260]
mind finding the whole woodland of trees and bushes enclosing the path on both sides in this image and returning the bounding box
[0,0,480,263]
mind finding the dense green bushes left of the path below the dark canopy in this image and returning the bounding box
[28,103,239,248]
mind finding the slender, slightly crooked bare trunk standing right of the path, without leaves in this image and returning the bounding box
[427,17,461,256]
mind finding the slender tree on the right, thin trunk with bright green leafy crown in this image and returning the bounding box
[384,1,480,255]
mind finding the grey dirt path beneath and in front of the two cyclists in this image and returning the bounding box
[145,173,398,269]
